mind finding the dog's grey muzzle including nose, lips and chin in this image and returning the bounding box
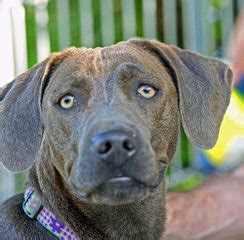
[70,124,166,204]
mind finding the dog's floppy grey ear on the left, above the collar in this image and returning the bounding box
[0,53,63,171]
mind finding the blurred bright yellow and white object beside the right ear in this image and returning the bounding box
[205,90,244,167]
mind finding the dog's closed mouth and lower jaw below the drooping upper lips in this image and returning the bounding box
[72,165,166,205]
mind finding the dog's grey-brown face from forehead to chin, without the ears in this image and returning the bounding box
[42,45,179,204]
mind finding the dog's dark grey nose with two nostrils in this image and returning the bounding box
[91,130,136,166]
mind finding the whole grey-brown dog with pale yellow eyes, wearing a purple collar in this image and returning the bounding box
[0,39,232,240]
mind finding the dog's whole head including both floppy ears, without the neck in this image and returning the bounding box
[0,40,232,204]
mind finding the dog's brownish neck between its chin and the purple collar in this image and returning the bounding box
[29,143,165,240]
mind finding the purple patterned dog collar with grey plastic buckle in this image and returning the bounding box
[22,188,78,240]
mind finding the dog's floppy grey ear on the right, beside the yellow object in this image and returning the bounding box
[131,40,232,149]
